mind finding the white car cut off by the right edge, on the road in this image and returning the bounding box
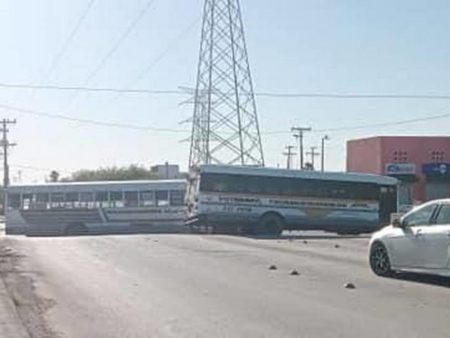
[369,199,450,277]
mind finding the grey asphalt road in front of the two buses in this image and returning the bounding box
[2,233,450,338]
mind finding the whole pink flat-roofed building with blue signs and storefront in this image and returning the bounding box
[347,136,450,204]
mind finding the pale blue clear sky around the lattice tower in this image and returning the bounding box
[0,0,450,183]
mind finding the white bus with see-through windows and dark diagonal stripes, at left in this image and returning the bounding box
[5,180,186,235]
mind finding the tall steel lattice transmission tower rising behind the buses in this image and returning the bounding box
[189,0,264,167]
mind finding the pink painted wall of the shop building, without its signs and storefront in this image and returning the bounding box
[347,136,450,201]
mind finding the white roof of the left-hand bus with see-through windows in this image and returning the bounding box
[7,179,186,192]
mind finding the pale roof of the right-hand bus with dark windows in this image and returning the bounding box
[200,164,398,185]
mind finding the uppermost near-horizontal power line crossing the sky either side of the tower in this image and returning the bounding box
[0,81,450,100]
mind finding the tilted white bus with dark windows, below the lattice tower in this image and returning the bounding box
[186,165,398,234]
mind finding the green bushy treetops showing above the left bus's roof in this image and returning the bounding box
[64,165,158,182]
